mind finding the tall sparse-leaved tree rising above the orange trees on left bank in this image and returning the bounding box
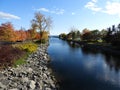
[31,12,52,40]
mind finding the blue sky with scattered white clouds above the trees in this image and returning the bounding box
[0,0,120,35]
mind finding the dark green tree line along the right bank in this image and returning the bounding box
[59,24,120,47]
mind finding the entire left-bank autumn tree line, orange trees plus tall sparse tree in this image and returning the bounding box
[0,12,52,42]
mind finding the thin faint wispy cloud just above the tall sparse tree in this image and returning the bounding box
[34,8,65,15]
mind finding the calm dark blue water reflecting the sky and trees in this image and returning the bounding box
[48,38,120,90]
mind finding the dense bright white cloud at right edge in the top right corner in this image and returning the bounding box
[103,2,120,16]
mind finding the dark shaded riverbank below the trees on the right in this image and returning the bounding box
[67,40,120,56]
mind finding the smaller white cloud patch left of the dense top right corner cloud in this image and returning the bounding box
[85,0,102,12]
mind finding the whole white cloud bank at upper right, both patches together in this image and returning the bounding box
[85,0,120,16]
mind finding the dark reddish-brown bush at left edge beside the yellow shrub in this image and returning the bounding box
[0,45,25,68]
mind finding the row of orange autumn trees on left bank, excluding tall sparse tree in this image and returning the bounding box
[0,22,43,42]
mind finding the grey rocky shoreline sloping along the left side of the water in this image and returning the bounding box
[0,44,58,90]
